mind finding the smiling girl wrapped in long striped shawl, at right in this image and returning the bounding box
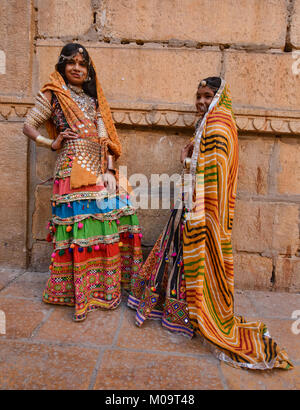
[128,77,293,370]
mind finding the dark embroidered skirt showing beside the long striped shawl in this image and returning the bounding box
[127,209,194,338]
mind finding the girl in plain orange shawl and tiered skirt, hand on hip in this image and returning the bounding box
[23,43,142,321]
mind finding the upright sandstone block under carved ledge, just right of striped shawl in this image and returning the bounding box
[238,137,274,195]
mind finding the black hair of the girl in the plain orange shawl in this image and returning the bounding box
[55,43,97,100]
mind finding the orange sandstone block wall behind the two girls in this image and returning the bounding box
[0,0,300,292]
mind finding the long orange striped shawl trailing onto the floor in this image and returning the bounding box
[183,80,293,369]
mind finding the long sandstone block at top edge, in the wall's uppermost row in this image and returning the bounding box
[101,0,287,48]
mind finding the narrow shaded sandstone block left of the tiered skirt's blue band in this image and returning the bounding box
[32,185,52,240]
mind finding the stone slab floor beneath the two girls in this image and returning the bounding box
[0,269,300,390]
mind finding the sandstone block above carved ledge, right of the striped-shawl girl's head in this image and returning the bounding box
[224,51,300,110]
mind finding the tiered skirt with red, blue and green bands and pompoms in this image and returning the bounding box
[43,178,142,321]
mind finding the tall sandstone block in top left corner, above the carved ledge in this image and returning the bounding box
[0,0,33,96]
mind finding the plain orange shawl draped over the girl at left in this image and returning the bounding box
[41,59,121,159]
